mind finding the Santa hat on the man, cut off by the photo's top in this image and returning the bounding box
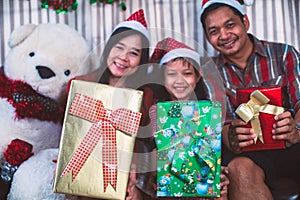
[200,0,254,16]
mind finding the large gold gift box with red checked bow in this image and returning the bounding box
[53,80,143,199]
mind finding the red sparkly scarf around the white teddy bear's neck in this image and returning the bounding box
[0,70,65,123]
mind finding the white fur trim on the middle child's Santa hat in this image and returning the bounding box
[159,48,200,66]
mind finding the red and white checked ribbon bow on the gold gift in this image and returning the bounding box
[61,93,141,192]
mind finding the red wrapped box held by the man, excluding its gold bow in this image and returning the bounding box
[236,86,286,151]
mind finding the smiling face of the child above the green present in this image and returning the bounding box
[164,59,200,100]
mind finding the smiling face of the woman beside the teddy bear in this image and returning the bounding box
[107,34,142,78]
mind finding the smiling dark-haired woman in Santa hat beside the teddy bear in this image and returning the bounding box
[76,9,150,200]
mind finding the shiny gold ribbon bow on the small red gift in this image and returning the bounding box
[235,90,284,143]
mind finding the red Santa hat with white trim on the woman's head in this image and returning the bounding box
[113,9,150,42]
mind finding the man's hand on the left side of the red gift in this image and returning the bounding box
[228,119,256,153]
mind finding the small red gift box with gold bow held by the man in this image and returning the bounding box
[236,86,285,151]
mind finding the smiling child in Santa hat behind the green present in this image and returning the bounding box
[130,38,229,199]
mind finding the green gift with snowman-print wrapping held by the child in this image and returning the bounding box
[154,100,222,197]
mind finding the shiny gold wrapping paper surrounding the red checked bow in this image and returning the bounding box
[53,80,143,199]
